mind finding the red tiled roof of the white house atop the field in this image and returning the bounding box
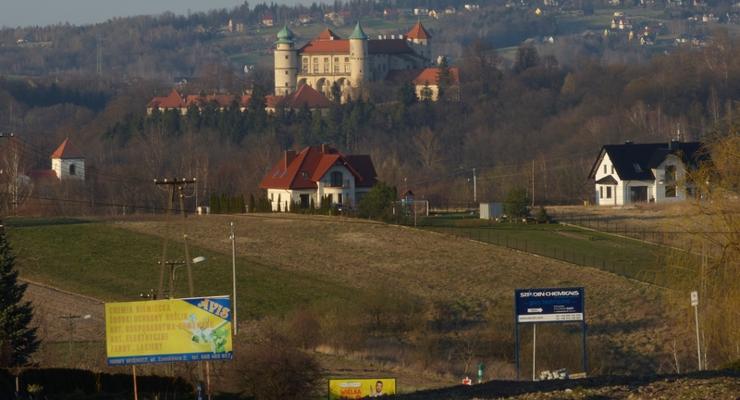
[260,145,376,189]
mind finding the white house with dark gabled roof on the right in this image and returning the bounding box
[588,140,707,206]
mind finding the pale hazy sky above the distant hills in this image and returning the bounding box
[0,0,300,27]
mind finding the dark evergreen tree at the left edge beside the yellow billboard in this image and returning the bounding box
[0,225,39,368]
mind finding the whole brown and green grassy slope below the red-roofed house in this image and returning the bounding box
[8,215,679,392]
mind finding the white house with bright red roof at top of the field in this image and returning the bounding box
[260,144,377,211]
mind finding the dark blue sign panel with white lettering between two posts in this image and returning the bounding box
[514,288,585,323]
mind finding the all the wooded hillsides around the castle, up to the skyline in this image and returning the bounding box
[0,2,740,214]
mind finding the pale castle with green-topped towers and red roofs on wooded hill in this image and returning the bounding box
[275,22,432,99]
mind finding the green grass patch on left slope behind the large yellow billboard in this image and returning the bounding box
[7,220,358,318]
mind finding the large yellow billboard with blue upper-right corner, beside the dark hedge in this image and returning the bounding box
[105,296,232,365]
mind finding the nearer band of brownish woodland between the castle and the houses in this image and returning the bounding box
[0,37,740,212]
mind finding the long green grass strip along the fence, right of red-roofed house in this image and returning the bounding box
[420,214,686,285]
